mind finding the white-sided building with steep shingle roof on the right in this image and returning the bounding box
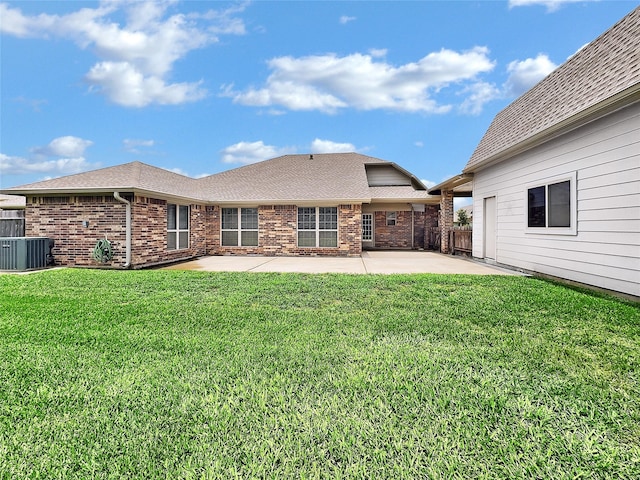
[464,8,640,296]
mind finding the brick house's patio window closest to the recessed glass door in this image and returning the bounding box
[298,207,338,247]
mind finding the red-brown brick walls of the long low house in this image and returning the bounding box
[25,194,438,268]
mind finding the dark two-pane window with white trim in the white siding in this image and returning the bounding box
[527,174,576,234]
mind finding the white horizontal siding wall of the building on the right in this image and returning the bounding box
[473,103,640,296]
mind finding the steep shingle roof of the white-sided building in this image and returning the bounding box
[464,7,640,172]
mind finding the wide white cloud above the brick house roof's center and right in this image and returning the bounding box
[223,47,495,113]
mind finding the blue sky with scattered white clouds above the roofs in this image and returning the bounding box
[0,0,637,204]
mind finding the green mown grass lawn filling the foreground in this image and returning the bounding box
[0,270,640,479]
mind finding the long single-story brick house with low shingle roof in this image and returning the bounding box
[4,153,440,268]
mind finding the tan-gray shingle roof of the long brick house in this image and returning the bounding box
[4,153,436,205]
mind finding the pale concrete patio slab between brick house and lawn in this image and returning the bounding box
[163,251,518,275]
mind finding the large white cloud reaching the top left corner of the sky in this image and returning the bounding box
[0,0,245,107]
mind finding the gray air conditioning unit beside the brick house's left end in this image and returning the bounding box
[0,237,50,271]
